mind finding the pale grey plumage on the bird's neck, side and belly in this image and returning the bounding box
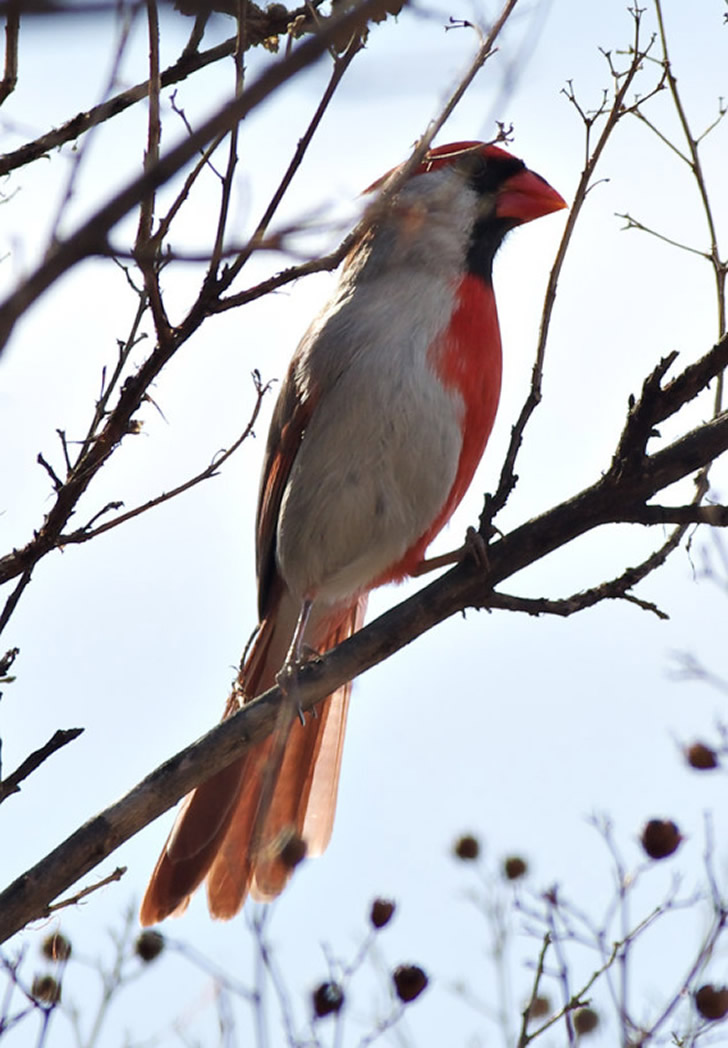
[277,171,477,603]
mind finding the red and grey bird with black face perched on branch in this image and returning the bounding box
[140,141,567,925]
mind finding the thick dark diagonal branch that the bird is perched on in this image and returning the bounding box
[0,337,728,941]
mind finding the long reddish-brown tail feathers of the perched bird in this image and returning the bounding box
[139,593,367,924]
